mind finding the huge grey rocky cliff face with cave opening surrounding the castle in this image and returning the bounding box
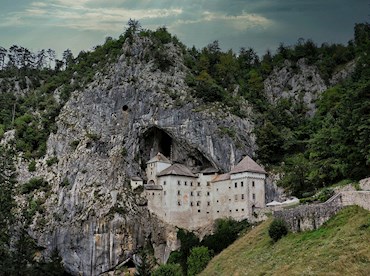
[18,34,255,275]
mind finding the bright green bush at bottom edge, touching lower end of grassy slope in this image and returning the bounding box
[187,246,211,276]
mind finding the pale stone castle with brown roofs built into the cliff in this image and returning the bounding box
[131,153,266,230]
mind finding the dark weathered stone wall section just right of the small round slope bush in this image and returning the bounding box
[274,202,342,232]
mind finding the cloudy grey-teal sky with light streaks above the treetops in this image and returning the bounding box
[0,0,370,56]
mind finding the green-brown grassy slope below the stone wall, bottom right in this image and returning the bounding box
[201,206,370,275]
